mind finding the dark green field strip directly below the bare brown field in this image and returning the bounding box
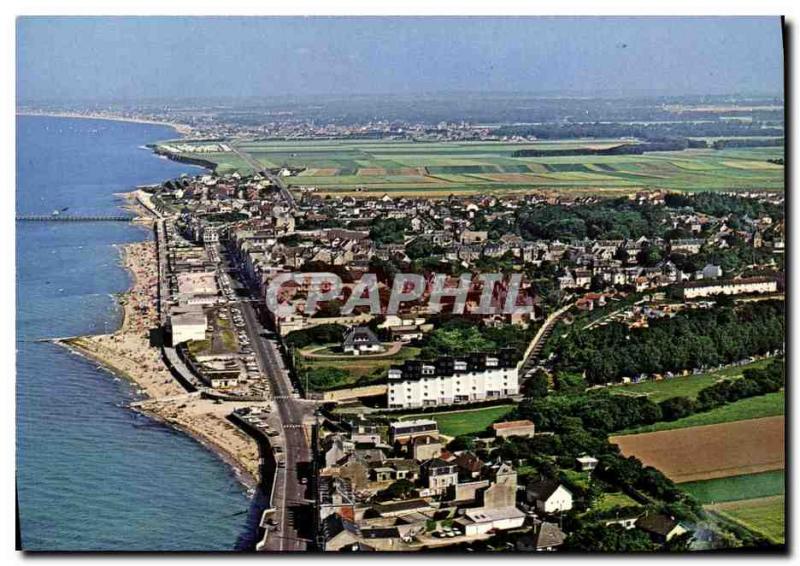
[680,470,785,505]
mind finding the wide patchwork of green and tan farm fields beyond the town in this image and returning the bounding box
[153,139,784,197]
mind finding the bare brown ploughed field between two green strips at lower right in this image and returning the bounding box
[609,416,785,483]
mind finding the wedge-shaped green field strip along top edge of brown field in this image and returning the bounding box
[615,391,786,436]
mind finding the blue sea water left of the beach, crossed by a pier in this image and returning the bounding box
[16,116,253,551]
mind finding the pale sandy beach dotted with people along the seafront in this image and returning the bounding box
[56,200,259,488]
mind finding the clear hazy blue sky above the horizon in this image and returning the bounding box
[17,17,783,101]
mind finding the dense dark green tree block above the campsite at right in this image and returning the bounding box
[555,300,785,384]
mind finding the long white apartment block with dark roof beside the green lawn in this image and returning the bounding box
[388,350,519,409]
